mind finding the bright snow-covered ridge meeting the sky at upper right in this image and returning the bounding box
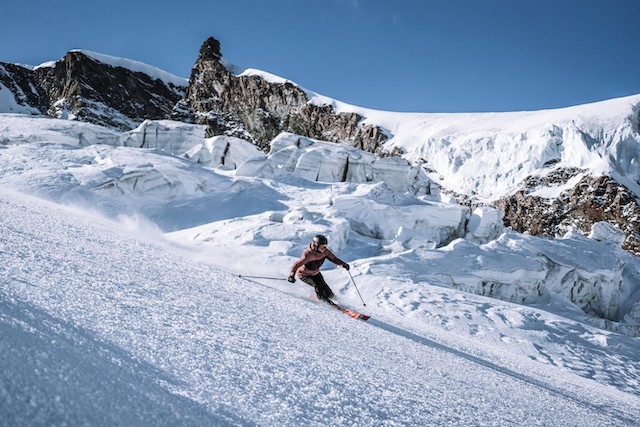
[225,65,640,201]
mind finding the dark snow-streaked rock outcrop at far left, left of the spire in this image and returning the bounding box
[0,51,185,130]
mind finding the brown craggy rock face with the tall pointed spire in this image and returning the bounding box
[180,38,387,152]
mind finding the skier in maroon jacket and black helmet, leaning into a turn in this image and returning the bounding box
[287,234,349,302]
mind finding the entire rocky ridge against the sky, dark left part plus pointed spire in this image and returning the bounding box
[0,37,388,152]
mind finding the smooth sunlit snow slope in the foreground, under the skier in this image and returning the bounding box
[0,191,640,426]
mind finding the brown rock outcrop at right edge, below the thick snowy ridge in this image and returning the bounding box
[497,169,640,255]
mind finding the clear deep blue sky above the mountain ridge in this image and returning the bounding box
[0,0,640,112]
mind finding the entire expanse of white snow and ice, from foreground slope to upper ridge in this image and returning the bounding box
[0,83,640,426]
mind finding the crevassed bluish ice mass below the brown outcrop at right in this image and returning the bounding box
[412,231,628,335]
